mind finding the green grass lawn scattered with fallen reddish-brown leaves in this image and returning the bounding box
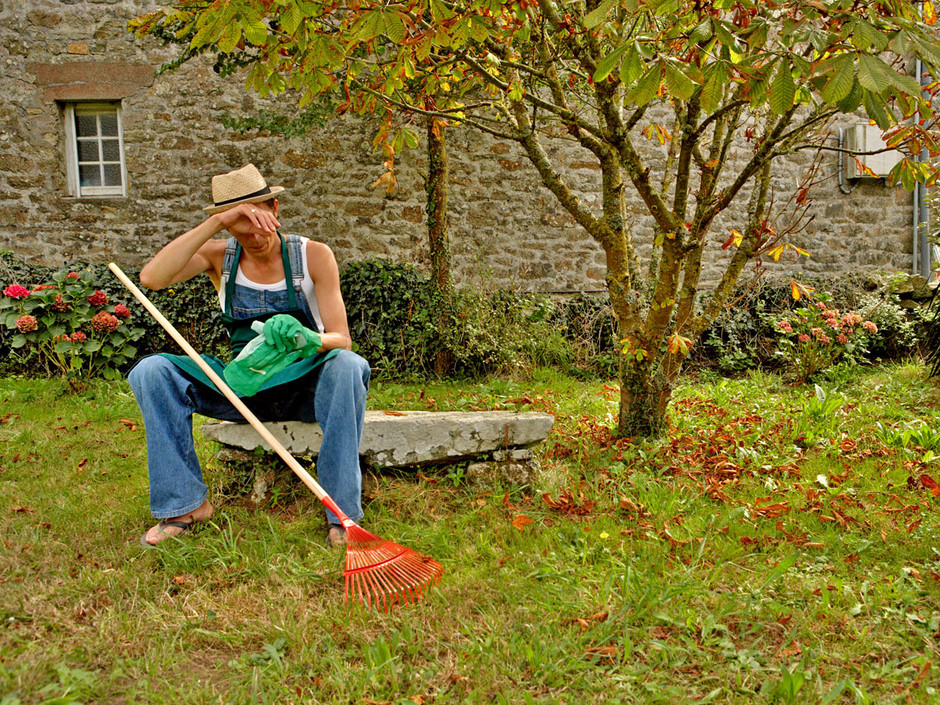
[0,363,940,705]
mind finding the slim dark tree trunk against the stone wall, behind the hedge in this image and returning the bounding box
[425,117,453,377]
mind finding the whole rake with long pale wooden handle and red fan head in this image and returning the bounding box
[108,262,444,612]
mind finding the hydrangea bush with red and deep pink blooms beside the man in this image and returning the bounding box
[0,271,144,378]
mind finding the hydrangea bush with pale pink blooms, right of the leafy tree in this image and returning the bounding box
[777,294,878,383]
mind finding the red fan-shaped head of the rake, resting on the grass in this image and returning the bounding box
[343,524,444,612]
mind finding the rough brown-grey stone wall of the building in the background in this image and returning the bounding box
[0,0,912,292]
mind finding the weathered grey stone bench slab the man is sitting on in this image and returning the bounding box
[202,411,555,468]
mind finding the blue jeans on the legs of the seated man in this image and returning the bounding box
[128,350,371,524]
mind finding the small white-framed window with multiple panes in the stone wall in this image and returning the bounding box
[65,103,127,197]
